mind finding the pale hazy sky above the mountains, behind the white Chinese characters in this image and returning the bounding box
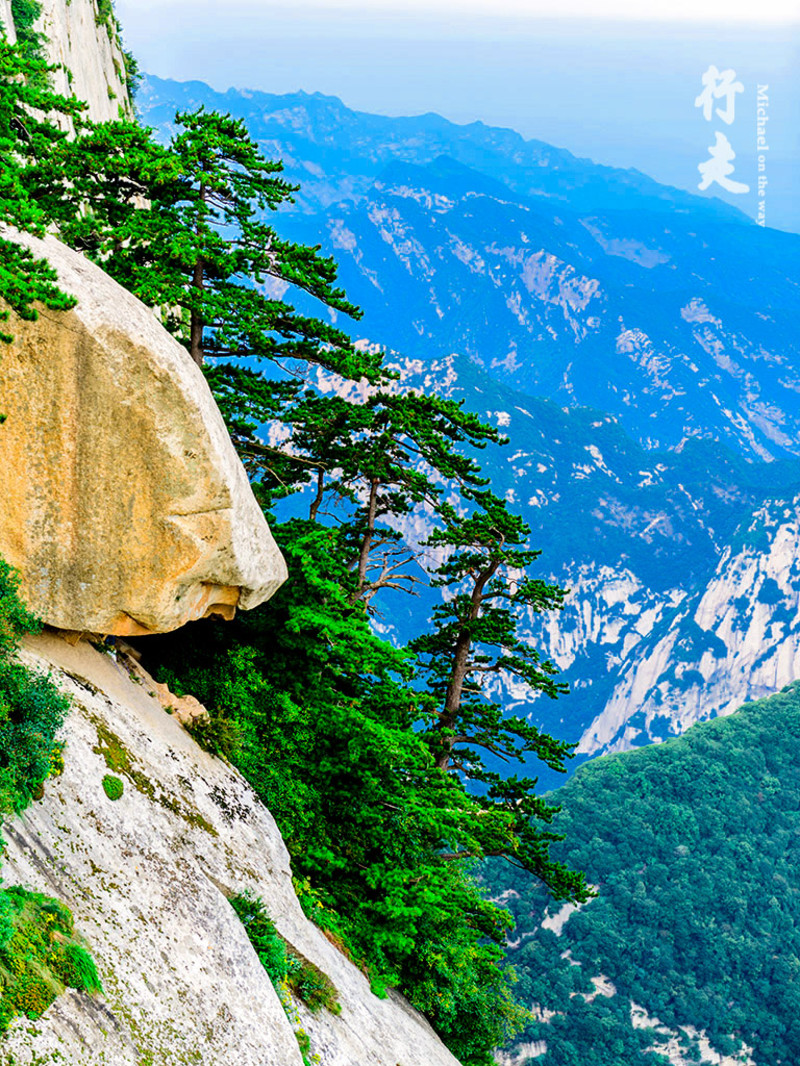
[116,0,800,230]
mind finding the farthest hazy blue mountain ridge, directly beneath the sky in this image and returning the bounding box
[137,75,754,226]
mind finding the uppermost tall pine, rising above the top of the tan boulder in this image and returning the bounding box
[42,108,381,377]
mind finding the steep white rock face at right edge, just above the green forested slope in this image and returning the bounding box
[579,497,800,755]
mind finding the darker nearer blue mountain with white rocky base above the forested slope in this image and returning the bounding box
[369,356,800,784]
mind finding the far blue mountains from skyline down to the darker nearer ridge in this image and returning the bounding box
[141,70,800,458]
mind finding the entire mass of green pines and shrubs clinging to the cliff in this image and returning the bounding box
[0,46,589,1066]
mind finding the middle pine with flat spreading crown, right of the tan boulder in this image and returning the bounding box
[209,364,503,607]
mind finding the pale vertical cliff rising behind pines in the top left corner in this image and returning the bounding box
[0,0,132,123]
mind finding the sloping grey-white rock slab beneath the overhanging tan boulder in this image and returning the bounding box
[0,634,458,1066]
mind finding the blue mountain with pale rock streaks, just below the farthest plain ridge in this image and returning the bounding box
[293,159,800,458]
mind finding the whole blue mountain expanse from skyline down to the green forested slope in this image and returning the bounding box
[139,78,800,776]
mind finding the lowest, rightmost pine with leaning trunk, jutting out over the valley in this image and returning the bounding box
[411,489,589,900]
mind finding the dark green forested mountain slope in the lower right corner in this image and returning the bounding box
[485,685,800,1066]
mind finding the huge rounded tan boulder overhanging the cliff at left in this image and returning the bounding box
[0,231,286,635]
